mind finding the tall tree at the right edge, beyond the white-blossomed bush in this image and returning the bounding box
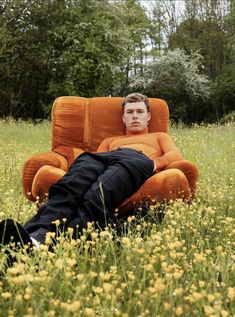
[153,0,232,121]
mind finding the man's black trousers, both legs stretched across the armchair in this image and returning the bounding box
[25,148,154,243]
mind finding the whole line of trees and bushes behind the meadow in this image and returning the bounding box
[0,0,235,123]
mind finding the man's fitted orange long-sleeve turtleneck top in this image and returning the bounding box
[97,131,183,171]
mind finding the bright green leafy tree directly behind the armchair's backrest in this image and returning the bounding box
[50,0,131,97]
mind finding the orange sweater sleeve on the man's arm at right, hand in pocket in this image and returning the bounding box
[154,133,183,172]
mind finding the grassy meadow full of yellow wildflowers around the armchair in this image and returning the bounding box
[0,121,235,317]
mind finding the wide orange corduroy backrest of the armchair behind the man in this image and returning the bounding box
[52,96,169,152]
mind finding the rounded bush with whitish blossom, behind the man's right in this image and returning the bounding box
[130,49,210,122]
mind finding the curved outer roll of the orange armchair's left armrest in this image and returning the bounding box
[22,152,69,201]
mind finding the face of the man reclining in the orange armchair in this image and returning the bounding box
[122,101,151,133]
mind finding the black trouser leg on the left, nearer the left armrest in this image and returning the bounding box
[25,153,107,242]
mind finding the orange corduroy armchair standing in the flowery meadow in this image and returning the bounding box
[22,97,198,213]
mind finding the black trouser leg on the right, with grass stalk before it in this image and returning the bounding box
[68,149,153,232]
